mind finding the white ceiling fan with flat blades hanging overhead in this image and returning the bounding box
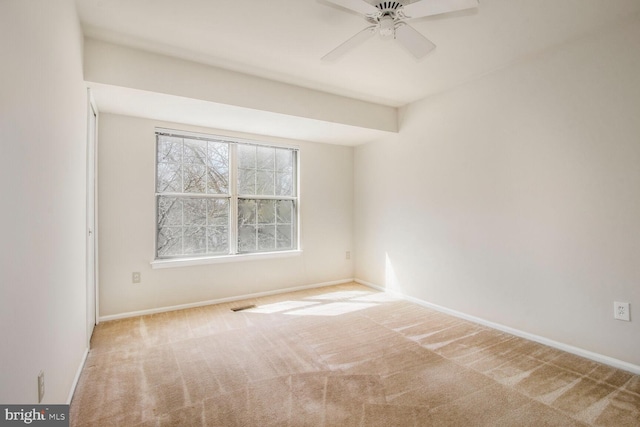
[322,0,478,61]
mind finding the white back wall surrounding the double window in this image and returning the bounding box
[98,114,353,316]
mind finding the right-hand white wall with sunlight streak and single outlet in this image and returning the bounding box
[354,15,640,365]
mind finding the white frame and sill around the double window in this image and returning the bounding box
[151,127,302,269]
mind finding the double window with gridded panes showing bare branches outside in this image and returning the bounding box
[156,130,298,259]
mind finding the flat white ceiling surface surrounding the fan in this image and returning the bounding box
[76,0,640,144]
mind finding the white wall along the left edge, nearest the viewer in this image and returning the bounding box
[0,0,87,403]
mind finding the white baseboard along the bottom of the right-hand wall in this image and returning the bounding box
[354,279,640,375]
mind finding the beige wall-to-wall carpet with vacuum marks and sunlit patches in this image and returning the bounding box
[71,283,640,427]
